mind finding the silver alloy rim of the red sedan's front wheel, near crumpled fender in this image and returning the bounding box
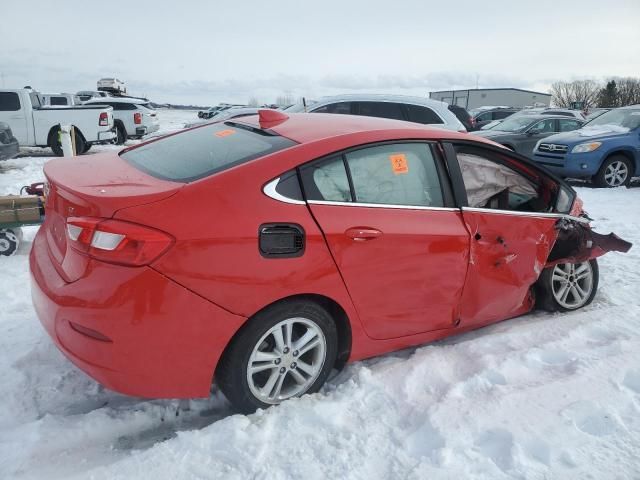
[551,262,593,310]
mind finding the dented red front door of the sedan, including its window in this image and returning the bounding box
[445,144,559,326]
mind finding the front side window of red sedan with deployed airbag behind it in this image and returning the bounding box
[456,146,552,212]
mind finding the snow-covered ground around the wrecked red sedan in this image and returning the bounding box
[0,111,640,480]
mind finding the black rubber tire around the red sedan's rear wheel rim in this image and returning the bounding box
[214,300,338,413]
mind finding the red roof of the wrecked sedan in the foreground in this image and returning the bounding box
[231,112,476,143]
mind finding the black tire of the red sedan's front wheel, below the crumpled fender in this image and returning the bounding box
[536,258,600,312]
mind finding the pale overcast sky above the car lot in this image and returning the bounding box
[0,0,640,105]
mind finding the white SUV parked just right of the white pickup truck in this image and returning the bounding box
[85,97,160,145]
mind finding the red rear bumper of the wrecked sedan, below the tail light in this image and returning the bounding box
[30,229,246,398]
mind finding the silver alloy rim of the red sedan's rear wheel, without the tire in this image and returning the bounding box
[247,317,327,404]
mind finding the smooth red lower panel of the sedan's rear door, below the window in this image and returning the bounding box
[310,204,469,339]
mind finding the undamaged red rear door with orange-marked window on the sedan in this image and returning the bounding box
[300,142,469,339]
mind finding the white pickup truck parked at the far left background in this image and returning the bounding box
[0,88,116,155]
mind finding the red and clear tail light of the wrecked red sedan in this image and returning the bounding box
[67,217,174,267]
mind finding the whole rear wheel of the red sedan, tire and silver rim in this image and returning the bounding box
[215,300,337,413]
